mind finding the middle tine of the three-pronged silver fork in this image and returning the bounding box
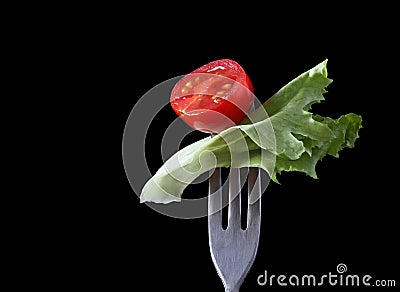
[228,168,241,228]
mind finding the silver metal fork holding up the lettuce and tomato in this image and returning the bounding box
[208,168,261,292]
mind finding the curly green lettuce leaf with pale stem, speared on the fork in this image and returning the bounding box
[140,60,362,203]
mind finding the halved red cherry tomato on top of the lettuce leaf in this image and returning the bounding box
[170,59,255,133]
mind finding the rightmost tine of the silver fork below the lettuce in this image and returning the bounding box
[247,167,261,228]
